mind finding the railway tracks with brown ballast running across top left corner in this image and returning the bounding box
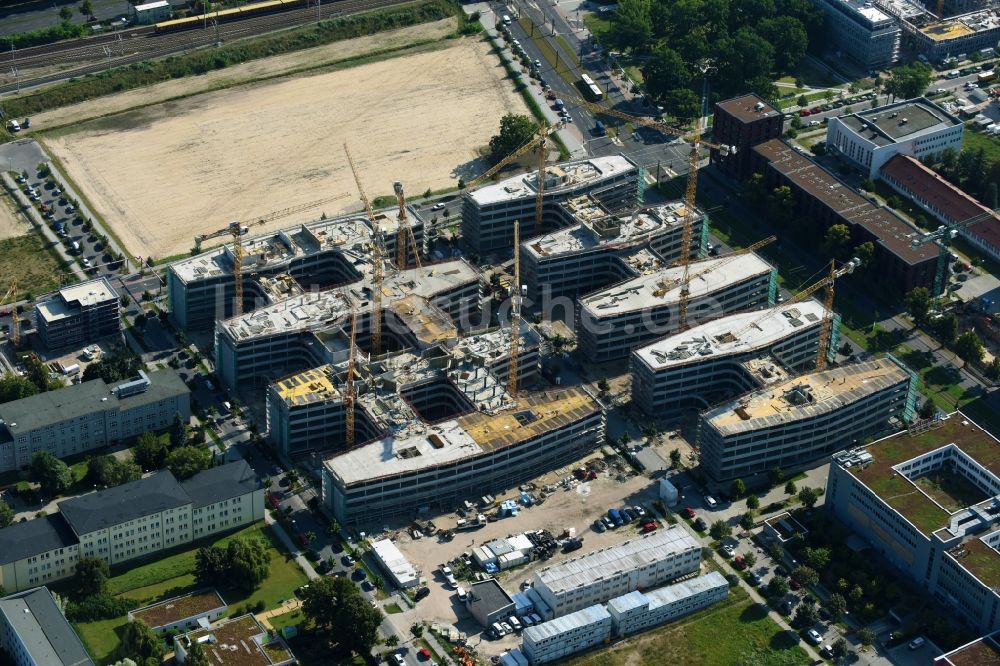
[0,0,407,94]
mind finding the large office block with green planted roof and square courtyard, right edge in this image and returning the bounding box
[825,412,1000,636]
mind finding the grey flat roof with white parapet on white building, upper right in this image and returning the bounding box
[837,97,962,146]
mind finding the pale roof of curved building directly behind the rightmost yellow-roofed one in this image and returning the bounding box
[633,299,826,370]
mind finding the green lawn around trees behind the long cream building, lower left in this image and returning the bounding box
[75,523,306,664]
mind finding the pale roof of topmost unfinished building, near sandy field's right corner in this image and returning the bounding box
[468,155,636,206]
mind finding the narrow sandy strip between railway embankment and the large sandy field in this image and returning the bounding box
[26,19,455,131]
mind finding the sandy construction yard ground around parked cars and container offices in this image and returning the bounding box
[396,456,657,654]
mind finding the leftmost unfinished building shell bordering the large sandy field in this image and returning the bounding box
[167,208,424,331]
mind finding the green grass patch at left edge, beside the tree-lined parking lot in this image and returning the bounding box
[0,232,76,299]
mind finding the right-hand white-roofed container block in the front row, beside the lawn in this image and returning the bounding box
[607,571,729,636]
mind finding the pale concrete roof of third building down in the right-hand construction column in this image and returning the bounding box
[580,252,773,318]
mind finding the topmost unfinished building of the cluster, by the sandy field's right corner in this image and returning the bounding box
[462,155,645,254]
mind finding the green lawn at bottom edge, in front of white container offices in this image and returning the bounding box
[568,588,809,666]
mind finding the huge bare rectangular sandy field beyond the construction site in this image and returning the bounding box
[43,30,525,258]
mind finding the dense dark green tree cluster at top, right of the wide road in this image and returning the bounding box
[603,0,825,120]
